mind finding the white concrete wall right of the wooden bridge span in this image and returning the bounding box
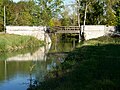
[81,25,116,40]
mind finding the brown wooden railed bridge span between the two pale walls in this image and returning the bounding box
[51,26,80,34]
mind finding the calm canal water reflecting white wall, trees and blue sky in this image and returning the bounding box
[0,40,76,90]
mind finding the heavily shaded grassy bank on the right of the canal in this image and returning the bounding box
[35,37,120,90]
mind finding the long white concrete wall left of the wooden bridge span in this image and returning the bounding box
[6,26,51,42]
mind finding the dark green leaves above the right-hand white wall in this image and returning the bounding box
[76,0,120,25]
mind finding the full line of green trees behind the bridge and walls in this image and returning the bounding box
[0,0,120,30]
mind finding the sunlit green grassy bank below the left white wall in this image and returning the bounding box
[0,34,43,52]
